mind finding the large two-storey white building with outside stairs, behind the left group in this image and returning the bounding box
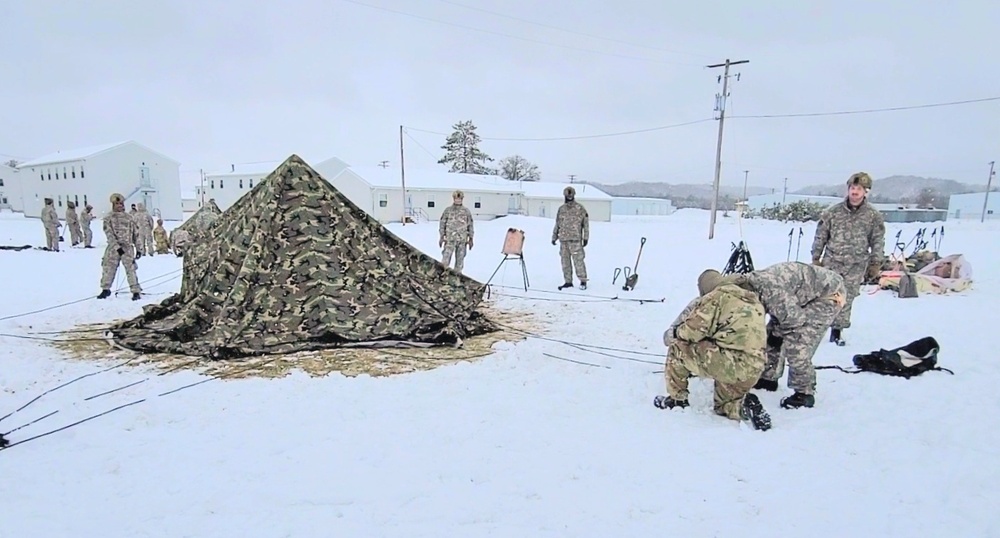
[17,141,183,220]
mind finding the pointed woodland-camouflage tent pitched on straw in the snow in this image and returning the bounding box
[112,155,496,359]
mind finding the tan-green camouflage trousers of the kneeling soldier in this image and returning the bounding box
[665,336,764,420]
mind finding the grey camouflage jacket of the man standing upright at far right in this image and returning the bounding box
[812,200,885,267]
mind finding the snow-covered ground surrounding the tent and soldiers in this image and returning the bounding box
[0,210,1000,538]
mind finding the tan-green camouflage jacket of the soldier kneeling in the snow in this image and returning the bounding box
[675,284,767,354]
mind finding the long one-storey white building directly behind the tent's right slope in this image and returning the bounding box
[315,159,521,223]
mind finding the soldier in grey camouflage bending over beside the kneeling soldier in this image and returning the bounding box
[726,262,846,409]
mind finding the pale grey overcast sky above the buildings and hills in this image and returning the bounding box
[0,0,1000,191]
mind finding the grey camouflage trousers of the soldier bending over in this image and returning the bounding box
[761,299,840,394]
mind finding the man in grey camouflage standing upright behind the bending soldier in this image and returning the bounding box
[812,172,885,345]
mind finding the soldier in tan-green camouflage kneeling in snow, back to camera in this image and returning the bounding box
[653,269,771,430]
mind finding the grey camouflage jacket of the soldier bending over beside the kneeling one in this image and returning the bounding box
[744,262,845,336]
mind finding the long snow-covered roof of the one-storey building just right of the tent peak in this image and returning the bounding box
[341,166,524,196]
